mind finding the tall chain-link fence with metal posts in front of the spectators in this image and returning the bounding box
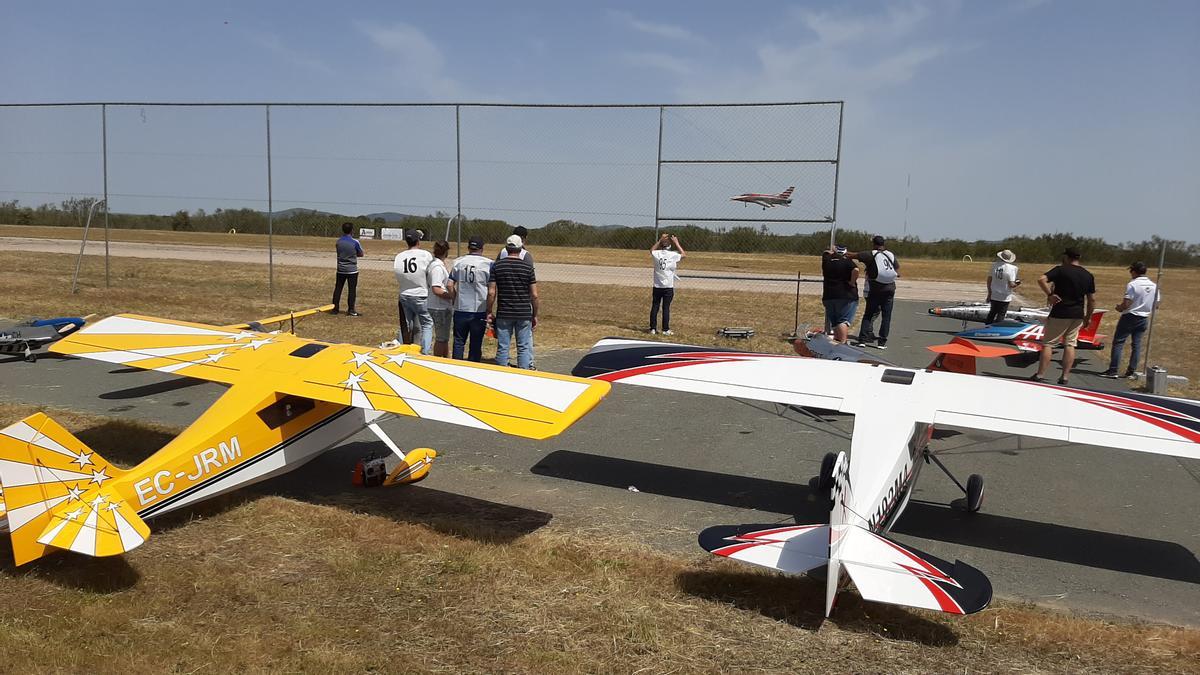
[0,102,842,312]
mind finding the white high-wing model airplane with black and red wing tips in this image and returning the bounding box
[572,338,1200,616]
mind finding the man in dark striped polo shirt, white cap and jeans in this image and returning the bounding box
[487,234,538,370]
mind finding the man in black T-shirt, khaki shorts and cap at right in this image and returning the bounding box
[1030,246,1096,384]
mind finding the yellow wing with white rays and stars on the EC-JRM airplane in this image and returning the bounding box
[52,315,608,438]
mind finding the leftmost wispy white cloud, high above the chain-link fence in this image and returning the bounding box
[354,22,466,101]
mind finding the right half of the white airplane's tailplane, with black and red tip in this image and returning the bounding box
[829,526,991,614]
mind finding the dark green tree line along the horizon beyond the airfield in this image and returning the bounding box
[0,198,1200,267]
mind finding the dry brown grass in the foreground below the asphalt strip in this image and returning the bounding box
[0,405,1200,673]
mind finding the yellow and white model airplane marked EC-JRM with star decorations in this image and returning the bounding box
[0,315,608,565]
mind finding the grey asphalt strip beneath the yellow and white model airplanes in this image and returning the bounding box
[0,303,1200,626]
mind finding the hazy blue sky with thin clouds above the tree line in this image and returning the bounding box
[0,0,1200,241]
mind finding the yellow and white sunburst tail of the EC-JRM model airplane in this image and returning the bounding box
[0,413,139,565]
